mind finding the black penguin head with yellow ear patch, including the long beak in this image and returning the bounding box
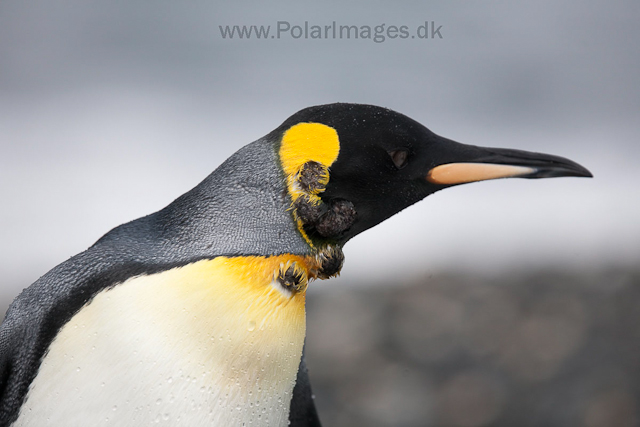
[276,103,592,244]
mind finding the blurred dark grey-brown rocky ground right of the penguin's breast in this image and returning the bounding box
[306,269,640,427]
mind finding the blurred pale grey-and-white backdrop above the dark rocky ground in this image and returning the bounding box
[0,0,640,297]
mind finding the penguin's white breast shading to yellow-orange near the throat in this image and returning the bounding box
[15,255,309,426]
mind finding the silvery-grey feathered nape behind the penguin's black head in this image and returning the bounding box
[97,135,310,262]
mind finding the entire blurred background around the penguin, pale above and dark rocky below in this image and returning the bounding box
[0,0,640,427]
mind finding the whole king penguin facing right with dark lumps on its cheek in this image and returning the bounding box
[0,103,591,427]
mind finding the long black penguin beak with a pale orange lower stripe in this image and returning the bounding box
[426,138,593,185]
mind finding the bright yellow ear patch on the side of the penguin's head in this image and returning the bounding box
[279,123,340,248]
